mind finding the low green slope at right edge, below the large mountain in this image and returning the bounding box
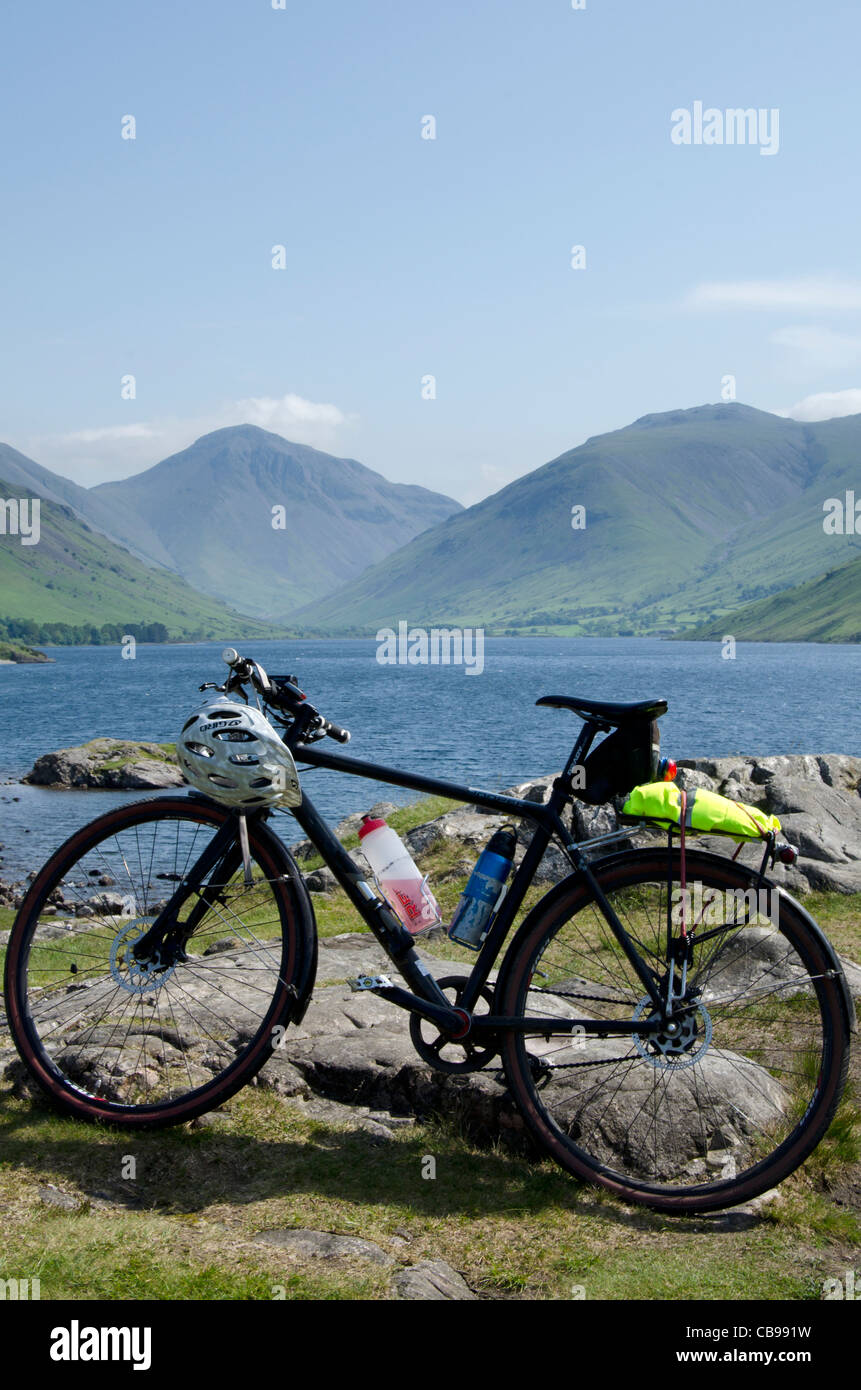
[679,555,861,642]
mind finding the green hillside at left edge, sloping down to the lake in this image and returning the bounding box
[0,478,282,638]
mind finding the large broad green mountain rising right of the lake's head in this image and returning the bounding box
[291,403,861,635]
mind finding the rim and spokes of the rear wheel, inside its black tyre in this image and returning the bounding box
[506,858,835,1200]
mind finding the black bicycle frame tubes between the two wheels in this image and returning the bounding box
[285,721,663,1036]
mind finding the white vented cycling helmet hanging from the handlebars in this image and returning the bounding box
[177,698,302,809]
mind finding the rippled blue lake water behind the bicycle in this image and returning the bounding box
[0,638,861,878]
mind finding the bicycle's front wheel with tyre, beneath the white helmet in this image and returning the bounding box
[6,796,316,1127]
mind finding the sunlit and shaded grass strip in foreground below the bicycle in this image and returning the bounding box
[0,1088,858,1301]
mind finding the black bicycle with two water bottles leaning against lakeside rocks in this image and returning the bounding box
[6,649,855,1212]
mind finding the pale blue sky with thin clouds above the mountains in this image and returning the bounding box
[0,0,861,502]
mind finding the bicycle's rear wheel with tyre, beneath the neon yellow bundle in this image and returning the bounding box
[497,849,850,1212]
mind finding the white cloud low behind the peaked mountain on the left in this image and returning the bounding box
[18,392,356,488]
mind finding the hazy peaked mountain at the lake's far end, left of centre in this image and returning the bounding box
[89,425,462,616]
